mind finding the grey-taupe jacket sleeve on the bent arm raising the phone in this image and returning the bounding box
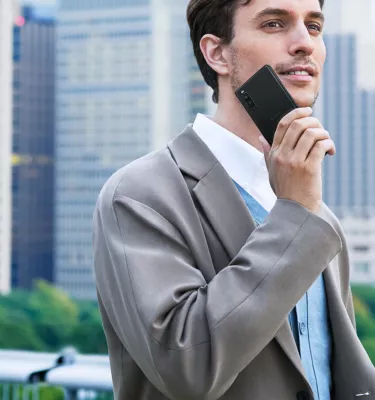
[94,193,341,400]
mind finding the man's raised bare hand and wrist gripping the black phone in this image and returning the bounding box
[260,108,336,213]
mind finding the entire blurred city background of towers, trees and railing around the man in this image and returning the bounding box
[0,0,375,400]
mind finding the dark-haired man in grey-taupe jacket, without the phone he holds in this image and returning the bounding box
[94,0,375,400]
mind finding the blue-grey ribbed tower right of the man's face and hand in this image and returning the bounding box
[321,34,375,218]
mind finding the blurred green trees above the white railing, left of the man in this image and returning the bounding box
[0,281,107,354]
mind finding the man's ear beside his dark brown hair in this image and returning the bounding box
[200,34,230,76]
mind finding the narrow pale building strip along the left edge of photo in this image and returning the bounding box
[0,0,17,293]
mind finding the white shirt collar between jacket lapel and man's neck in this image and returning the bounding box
[193,114,277,212]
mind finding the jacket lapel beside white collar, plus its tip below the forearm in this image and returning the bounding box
[168,126,308,385]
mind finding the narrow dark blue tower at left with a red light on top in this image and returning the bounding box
[12,7,55,289]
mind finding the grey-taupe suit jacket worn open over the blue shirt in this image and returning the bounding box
[94,126,375,400]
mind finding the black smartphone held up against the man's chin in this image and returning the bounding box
[236,65,297,145]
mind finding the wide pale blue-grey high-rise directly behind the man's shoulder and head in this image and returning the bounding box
[55,0,209,299]
